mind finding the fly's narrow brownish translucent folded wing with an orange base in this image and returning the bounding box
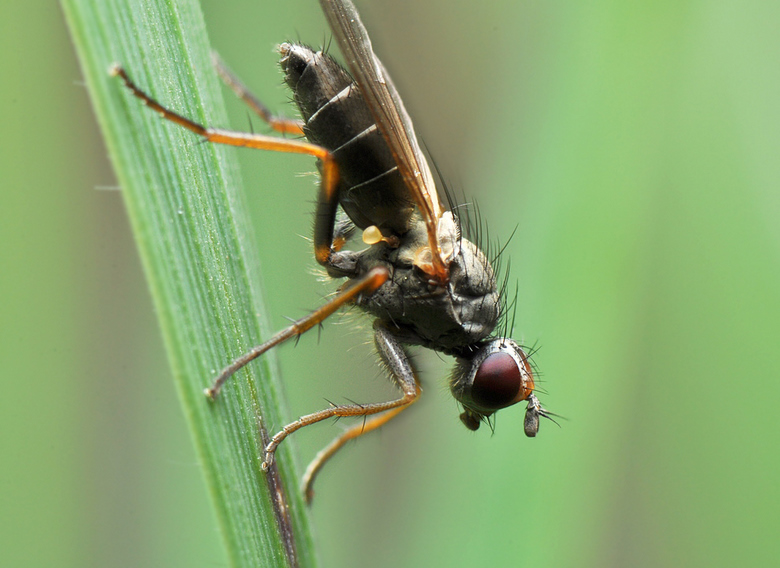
[320,0,448,282]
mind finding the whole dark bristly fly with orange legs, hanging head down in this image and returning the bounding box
[111,0,552,501]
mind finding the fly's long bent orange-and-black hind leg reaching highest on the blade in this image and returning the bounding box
[109,64,344,276]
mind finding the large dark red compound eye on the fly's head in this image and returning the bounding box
[471,352,523,410]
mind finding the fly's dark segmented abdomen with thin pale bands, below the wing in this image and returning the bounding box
[280,44,414,235]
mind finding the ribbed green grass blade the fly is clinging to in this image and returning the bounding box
[62,0,315,566]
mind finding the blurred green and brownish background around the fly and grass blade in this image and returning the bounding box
[0,0,780,567]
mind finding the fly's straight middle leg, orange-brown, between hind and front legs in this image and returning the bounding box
[205,267,390,398]
